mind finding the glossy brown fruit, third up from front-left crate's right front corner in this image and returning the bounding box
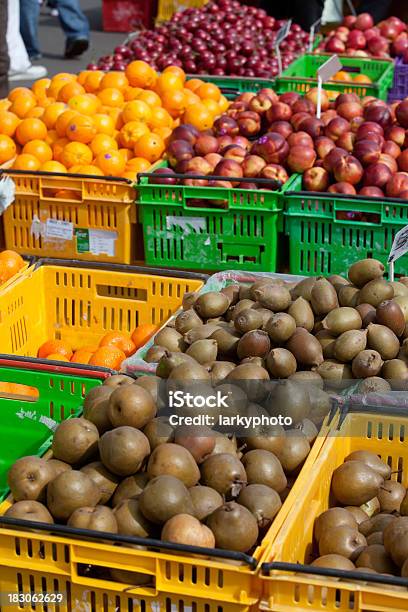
[242,449,287,493]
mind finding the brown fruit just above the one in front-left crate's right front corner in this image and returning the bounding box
[237,484,282,530]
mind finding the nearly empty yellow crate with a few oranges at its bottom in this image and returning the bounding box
[0,260,207,357]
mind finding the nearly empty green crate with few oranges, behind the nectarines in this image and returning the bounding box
[275,53,394,100]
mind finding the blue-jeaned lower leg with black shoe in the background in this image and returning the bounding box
[56,0,89,57]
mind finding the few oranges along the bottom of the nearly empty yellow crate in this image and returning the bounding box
[37,323,157,370]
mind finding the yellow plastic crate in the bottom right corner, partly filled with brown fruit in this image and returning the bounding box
[260,414,408,612]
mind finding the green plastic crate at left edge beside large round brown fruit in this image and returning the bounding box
[0,355,109,500]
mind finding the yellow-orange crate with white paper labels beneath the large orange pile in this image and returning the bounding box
[3,170,143,264]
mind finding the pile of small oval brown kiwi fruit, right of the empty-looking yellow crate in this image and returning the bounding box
[145,259,408,394]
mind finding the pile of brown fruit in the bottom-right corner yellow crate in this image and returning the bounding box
[311,450,408,590]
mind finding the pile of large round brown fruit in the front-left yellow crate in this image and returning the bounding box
[6,366,327,579]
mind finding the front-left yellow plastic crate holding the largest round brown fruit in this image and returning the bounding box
[0,414,334,612]
